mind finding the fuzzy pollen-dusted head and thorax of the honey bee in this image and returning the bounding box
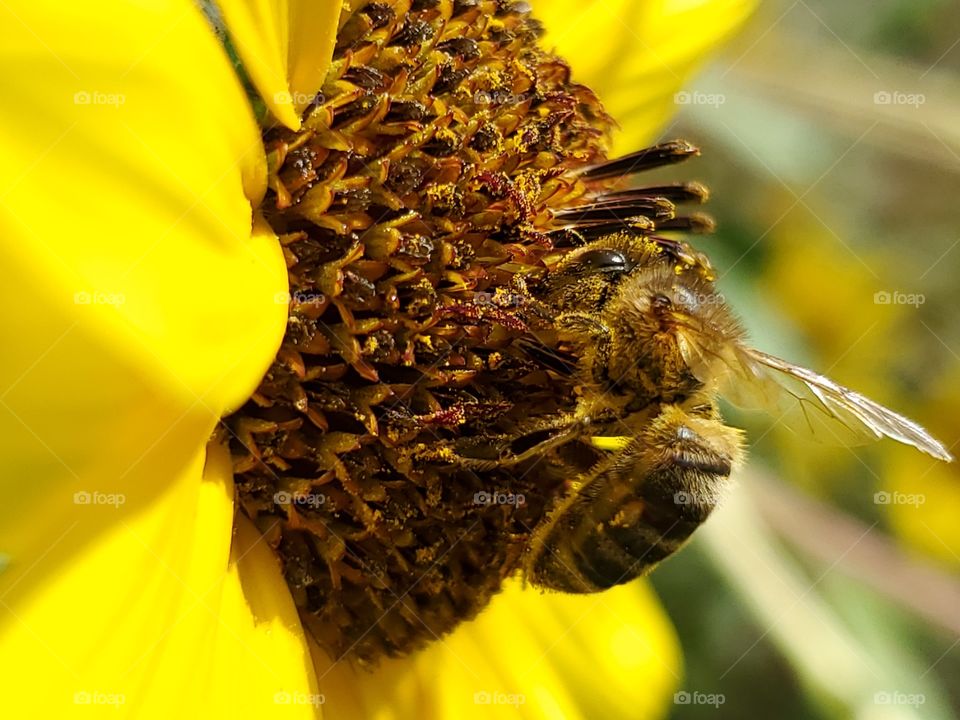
[543,234,742,406]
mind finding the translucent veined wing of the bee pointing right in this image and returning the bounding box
[681,333,953,462]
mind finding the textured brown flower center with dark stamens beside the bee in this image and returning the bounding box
[225,0,702,661]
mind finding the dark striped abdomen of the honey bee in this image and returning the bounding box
[524,405,741,593]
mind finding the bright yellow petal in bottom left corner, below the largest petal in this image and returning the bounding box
[0,448,318,719]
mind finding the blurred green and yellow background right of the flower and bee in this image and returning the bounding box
[644,0,960,720]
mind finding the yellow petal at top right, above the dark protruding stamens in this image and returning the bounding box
[536,0,756,154]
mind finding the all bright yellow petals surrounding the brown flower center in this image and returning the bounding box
[0,0,749,718]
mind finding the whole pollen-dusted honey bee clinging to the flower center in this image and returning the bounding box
[464,200,952,593]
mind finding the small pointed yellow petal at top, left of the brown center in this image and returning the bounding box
[218,0,340,130]
